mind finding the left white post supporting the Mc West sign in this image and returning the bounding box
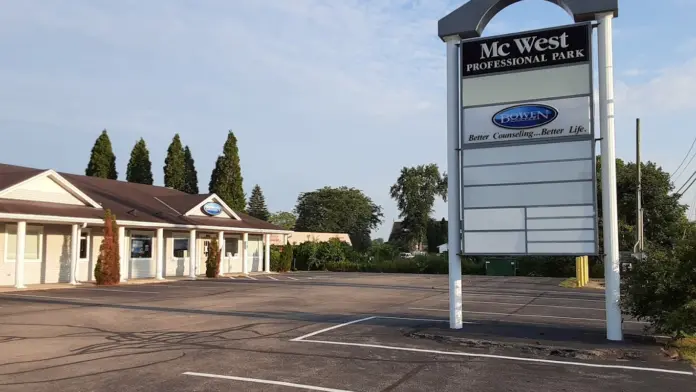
[446,37,462,329]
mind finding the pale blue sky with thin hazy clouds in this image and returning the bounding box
[0,0,696,238]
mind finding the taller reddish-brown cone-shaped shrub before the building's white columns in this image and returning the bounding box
[94,210,121,285]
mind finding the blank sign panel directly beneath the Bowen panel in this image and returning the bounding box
[462,140,594,167]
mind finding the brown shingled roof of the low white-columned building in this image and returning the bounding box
[0,164,287,231]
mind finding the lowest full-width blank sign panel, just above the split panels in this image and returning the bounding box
[462,181,594,209]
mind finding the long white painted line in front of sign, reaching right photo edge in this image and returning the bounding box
[301,340,694,376]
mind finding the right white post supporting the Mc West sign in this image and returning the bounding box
[597,12,623,340]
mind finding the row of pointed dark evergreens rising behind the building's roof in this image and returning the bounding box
[85,130,270,221]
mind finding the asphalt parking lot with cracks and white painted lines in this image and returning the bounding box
[0,273,696,392]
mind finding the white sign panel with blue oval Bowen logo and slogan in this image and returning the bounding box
[463,97,591,144]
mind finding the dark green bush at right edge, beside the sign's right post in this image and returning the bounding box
[621,230,696,337]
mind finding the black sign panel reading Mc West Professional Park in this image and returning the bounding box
[461,23,591,79]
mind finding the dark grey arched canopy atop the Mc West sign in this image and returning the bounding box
[437,0,619,39]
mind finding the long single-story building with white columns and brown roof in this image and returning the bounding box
[0,164,291,288]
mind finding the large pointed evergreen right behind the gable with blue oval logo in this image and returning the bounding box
[208,131,246,211]
